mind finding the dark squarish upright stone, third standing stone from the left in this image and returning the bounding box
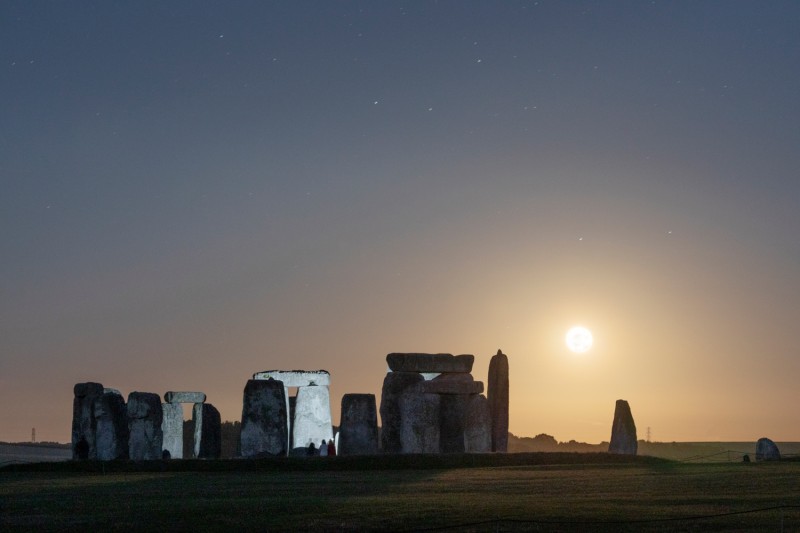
[128,392,163,461]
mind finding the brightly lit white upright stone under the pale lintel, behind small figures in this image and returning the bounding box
[292,386,333,448]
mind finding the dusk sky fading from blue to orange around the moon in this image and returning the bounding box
[0,0,800,443]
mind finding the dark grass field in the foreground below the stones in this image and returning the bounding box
[0,454,800,531]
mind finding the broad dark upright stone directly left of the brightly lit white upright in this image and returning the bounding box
[241,379,289,457]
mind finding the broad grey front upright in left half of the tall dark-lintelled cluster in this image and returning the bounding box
[399,382,442,453]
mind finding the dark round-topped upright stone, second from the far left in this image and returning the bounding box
[94,389,128,461]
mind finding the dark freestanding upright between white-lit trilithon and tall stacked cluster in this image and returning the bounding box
[337,394,379,455]
